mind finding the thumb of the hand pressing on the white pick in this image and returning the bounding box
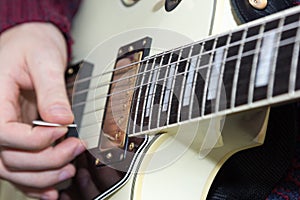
[27,26,74,124]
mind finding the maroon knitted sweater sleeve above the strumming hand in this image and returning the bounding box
[0,0,80,55]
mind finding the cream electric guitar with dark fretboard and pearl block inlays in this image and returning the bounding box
[61,0,300,200]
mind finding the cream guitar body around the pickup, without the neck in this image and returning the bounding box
[62,0,300,200]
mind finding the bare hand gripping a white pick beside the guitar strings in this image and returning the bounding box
[0,23,84,199]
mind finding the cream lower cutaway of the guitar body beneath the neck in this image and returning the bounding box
[108,110,268,200]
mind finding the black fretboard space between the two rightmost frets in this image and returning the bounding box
[272,15,299,96]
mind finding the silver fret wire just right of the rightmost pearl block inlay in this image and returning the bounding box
[267,18,285,99]
